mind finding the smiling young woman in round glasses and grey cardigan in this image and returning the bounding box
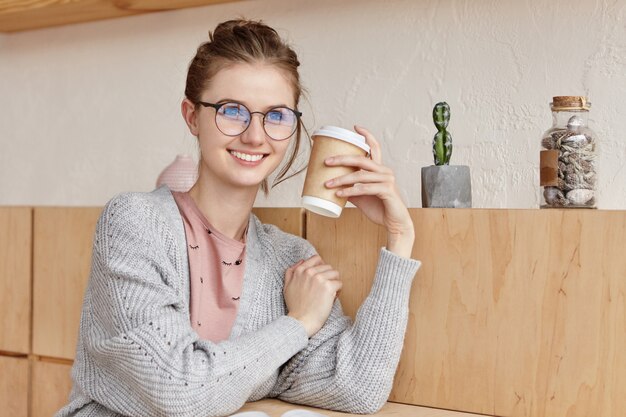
[58,20,419,417]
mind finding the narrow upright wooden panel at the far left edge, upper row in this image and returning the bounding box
[0,207,32,354]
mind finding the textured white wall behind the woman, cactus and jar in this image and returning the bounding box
[0,0,626,209]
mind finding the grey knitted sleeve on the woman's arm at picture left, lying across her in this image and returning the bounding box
[66,195,308,417]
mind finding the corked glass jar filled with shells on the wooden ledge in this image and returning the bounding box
[540,96,598,208]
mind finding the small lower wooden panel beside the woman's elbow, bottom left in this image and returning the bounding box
[31,360,72,417]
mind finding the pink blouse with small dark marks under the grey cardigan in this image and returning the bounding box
[172,192,246,343]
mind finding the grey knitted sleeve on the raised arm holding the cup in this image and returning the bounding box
[270,248,420,414]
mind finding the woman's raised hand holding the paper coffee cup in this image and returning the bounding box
[326,126,415,257]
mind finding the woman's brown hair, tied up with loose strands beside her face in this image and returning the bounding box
[185,19,310,195]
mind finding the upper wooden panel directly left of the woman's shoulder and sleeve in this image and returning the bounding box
[33,207,102,359]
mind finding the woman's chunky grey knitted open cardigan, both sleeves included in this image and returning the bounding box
[57,187,420,417]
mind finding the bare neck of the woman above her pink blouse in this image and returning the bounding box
[189,177,258,240]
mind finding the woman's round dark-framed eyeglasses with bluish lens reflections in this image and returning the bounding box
[198,101,302,140]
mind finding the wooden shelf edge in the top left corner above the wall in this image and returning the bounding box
[0,0,232,32]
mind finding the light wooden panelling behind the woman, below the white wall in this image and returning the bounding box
[0,207,626,417]
